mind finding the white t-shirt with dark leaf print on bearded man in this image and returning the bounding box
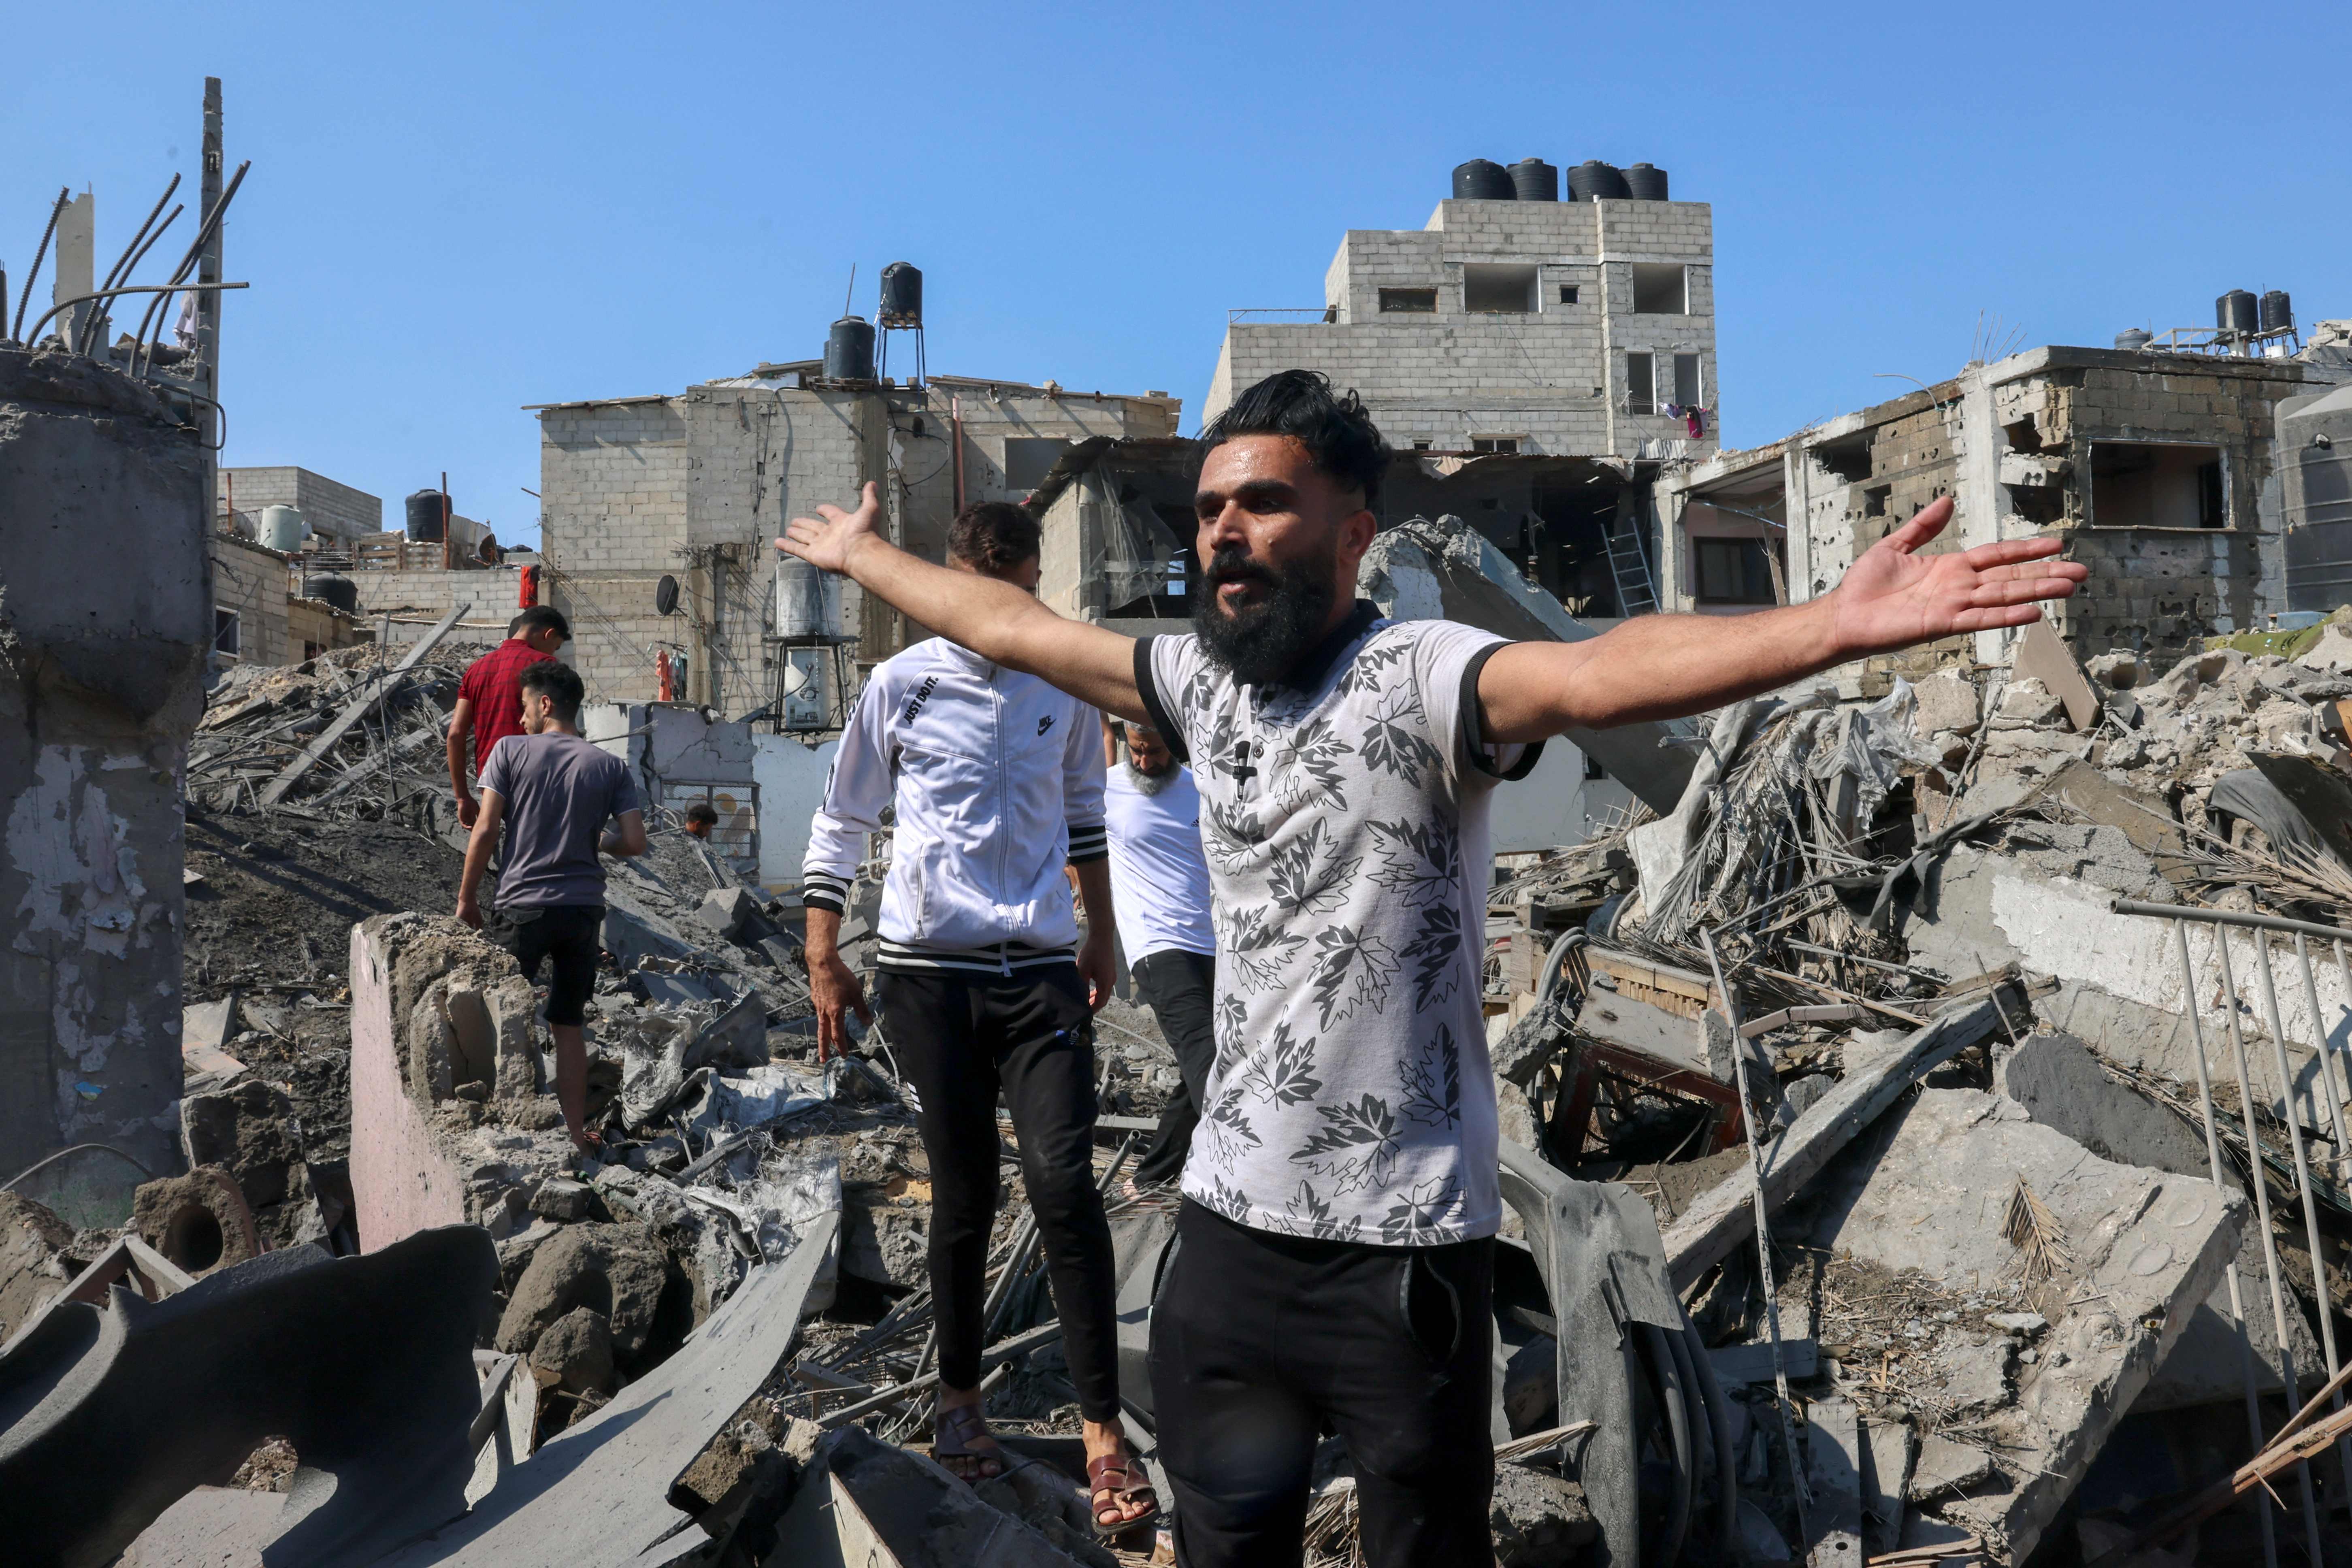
[1136,602,1540,1246]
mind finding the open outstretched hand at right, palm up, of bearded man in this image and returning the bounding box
[1825,496,2091,658]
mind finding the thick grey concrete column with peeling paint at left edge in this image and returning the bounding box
[0,350,212,1173]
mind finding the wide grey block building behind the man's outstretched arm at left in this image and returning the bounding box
[539,362,1181,729]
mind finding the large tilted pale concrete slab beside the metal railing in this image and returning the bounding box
[1790,1089,2248,1563]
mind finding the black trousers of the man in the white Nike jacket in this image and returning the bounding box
[875,964,1120,1420]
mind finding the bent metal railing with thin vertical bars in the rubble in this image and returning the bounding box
[2114,898,2352,1563]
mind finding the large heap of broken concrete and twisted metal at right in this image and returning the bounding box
[1489,633,2352,1563]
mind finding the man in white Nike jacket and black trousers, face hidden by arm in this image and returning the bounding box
[802,501,1157,1535]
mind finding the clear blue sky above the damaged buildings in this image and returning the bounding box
[0,0,2352,541]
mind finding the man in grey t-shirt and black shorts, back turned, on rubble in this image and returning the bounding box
[456,658,644,1152]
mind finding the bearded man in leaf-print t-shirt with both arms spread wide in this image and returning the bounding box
[776,371,2089,1568]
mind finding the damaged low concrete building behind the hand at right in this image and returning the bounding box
[1656,345,2324,670]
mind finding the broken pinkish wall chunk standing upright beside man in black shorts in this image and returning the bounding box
[350,914,571,1251]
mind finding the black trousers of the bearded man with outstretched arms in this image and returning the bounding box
[1153,1201,1493,1568]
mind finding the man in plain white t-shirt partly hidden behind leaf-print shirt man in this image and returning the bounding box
[1103,719,1216,1187]
